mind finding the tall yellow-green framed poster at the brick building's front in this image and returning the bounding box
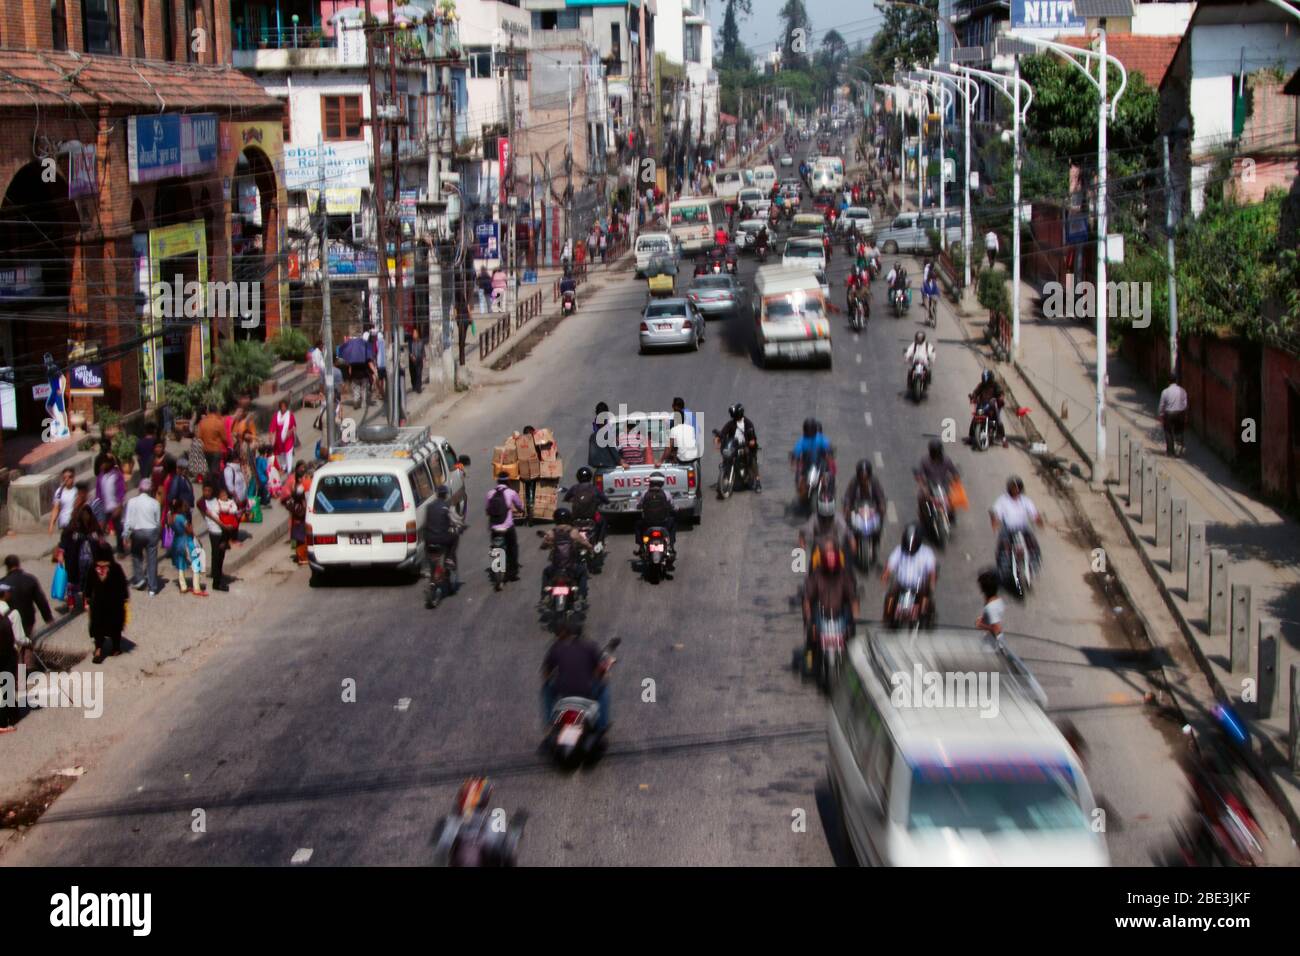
[142,219,212,402]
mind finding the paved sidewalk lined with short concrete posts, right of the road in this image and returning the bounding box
[966,267,1300,826]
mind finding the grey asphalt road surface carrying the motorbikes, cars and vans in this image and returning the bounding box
[5,141,1183,865]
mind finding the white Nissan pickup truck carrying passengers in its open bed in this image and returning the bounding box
[595,412,705,524]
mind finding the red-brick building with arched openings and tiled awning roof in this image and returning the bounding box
[0,0,285,437]
